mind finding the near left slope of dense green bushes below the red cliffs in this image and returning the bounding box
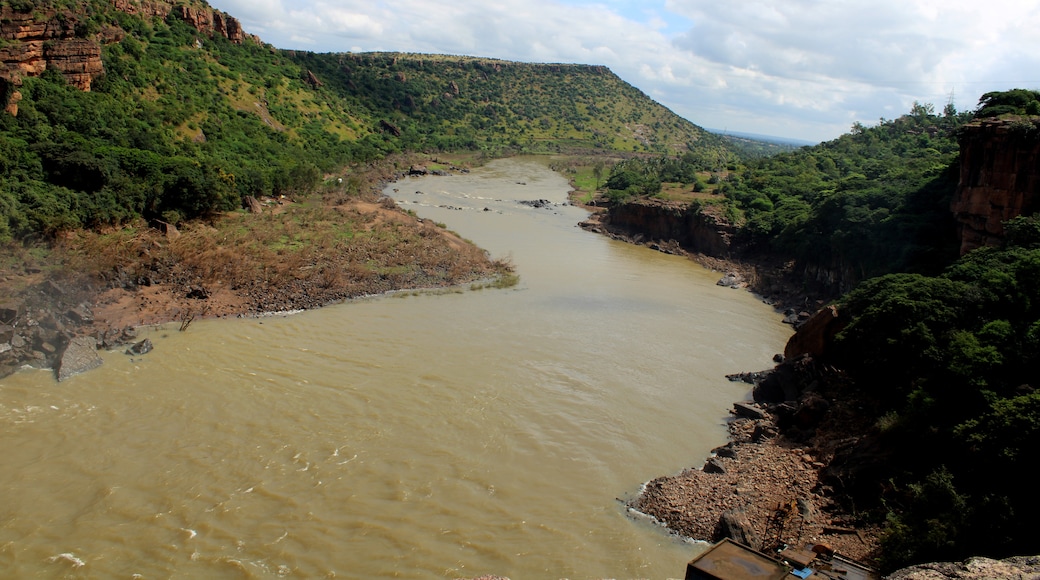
[0,14,356,243]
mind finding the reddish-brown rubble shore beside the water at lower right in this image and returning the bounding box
[627,359,881,565]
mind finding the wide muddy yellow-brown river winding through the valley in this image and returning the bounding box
[0,159,790,580]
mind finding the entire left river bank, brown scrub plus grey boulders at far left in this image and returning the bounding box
[0,156,512,376]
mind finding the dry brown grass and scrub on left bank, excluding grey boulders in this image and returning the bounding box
[42,154,515,322]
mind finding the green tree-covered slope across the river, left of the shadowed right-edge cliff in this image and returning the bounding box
[607,104,972,292]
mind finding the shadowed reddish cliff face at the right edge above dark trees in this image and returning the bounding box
[951,117,1040,255]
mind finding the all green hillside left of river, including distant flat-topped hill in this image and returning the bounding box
[0,0,721,241]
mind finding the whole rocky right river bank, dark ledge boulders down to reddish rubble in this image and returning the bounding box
[569,193,882,565]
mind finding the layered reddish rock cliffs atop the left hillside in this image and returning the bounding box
[0,0,259,114]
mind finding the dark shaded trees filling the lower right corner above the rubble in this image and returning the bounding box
[836,216,1040,569]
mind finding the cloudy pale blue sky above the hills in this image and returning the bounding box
[202,0,1040,141]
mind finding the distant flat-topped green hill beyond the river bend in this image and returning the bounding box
[293,53,721,155]
